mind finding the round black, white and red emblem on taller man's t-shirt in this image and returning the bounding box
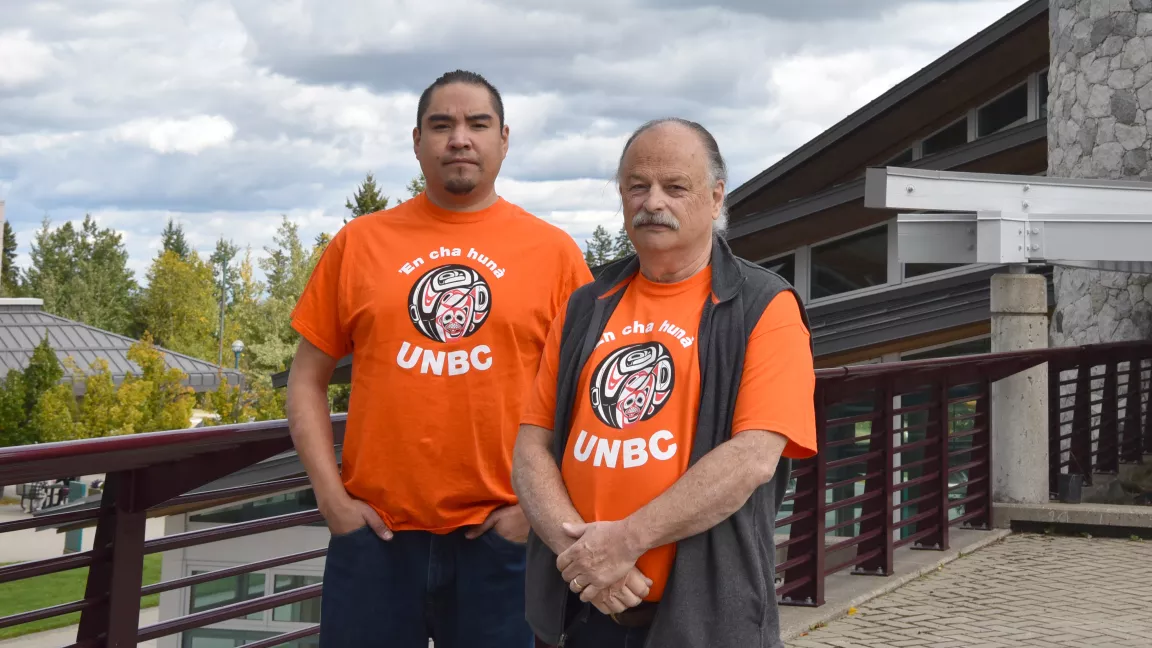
[408,264,492,342]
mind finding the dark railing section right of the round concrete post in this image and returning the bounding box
[1048,341,1152,486]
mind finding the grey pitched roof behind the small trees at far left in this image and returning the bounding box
[0,299,240,393]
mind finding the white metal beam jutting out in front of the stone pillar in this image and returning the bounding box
[864,167,1152,269]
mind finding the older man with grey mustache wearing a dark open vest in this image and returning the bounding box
[513,119,817,648]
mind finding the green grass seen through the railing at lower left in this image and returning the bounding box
[0,553,161,639]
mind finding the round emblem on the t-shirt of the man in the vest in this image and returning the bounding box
[591,342,675,429]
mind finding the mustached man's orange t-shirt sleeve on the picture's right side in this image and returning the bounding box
[732,292,817,459]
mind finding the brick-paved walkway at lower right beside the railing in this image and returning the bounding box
[787,535,1152,648]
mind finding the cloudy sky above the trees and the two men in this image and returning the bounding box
[0,0,1021,279]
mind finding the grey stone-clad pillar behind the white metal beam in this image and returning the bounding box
[1048,0,1152,346]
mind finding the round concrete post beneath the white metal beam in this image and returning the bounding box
[991,273,1048,504]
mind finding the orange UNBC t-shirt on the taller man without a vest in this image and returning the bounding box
[291,194,592,533]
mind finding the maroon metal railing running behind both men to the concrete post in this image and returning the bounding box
[0,349,1133,648]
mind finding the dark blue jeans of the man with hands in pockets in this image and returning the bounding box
[320,527,535,648]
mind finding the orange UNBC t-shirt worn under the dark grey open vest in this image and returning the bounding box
[522,268,816,601]
